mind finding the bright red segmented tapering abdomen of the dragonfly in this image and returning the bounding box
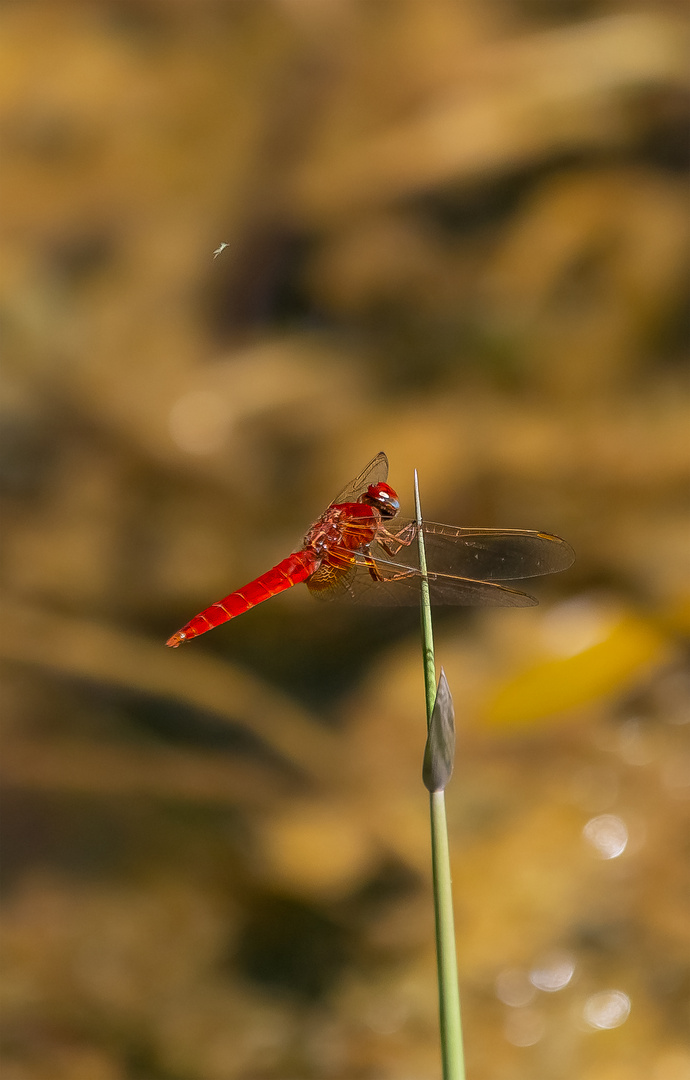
[165,550,321,649]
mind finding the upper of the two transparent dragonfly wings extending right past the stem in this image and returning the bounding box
[377,518,574,581]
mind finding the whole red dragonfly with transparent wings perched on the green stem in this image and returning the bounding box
[166,451,574,649]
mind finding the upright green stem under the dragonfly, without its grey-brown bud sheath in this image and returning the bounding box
[415,472,465,1080]
